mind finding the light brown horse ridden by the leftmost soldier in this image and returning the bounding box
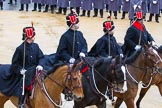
[0,63,84,108]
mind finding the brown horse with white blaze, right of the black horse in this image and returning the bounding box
[114,47,162,108]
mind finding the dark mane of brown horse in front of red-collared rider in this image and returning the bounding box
[125,49,142,64]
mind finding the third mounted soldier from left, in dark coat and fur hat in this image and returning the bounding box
[88,16,123,58]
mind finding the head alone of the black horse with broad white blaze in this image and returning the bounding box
[109,56,127,93]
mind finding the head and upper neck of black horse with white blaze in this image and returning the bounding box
[94,56,127,92]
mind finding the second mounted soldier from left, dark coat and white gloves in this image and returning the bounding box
[56,11,87,63]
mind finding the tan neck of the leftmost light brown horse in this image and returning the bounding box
[44,67,67,104]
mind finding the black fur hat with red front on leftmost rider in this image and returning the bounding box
[22,27,35,40]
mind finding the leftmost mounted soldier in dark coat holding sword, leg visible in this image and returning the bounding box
[10,23,44,108]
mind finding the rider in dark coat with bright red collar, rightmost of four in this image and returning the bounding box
[122,11,156,56]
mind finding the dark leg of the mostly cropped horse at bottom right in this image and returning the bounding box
[136,87,150,108]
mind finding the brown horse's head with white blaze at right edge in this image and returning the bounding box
[144,46,162,69]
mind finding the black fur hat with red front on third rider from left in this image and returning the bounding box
[103,15,115,32]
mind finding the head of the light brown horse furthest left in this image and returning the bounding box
[67,62,84,100]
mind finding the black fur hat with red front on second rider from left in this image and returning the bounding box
[66,9,79,27]
